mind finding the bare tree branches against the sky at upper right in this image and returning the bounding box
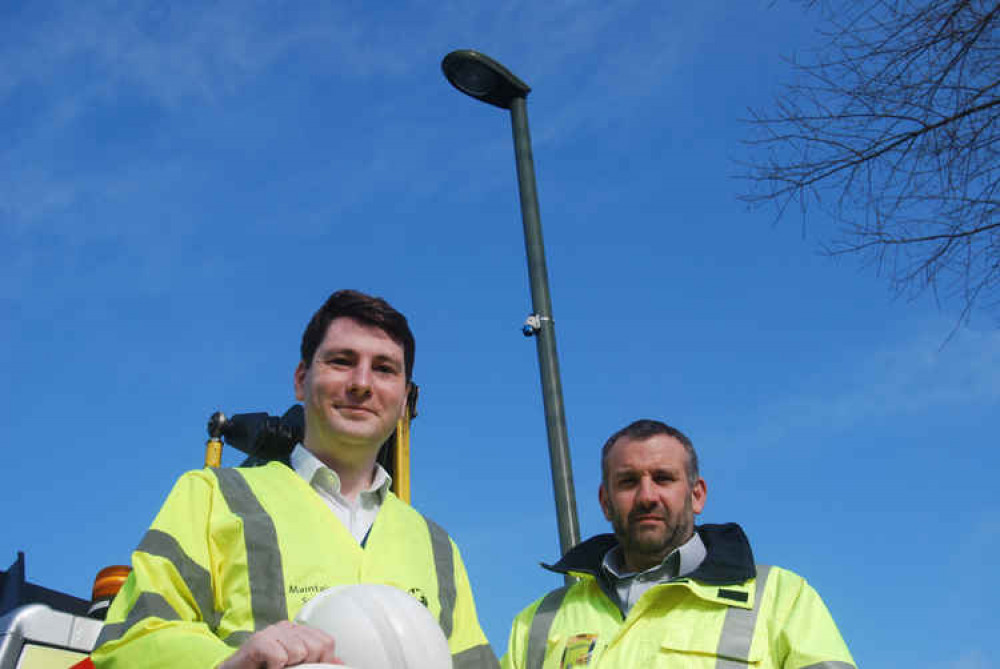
[741,0,1000,321]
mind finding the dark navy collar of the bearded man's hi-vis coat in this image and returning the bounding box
[542,523,757,584]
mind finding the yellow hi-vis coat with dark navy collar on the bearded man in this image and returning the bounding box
[501,523,855,669]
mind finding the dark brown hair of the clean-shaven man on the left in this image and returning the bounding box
[299,290,417,382]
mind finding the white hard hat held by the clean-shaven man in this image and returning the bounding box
[295,583,452,669]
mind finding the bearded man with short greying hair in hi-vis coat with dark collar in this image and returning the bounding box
[501,420,855,669]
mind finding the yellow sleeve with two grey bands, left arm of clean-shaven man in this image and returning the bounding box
[92,472,235,669]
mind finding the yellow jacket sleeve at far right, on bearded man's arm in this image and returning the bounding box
[771,569,856,669]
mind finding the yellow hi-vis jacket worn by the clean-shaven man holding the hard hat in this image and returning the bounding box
[92,462,497,669]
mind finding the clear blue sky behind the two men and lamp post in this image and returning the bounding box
[0,0,1000,669]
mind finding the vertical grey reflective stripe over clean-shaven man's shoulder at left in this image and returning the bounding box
[211,469,288,632]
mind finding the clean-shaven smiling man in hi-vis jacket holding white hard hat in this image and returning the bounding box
[93,290,497,669]
